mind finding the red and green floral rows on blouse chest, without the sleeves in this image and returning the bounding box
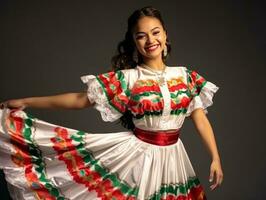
[129,77,190,119]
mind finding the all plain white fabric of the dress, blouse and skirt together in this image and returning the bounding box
[0,67,218,200]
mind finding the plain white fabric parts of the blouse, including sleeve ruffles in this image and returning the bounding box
[81,66,219,130]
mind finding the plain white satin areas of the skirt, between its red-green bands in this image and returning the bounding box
[0,110,195,200]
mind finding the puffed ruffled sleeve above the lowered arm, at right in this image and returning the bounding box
[186,69,219,117]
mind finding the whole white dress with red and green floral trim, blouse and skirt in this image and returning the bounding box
[0,66,218,200]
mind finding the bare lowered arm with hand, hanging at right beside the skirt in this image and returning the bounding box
[191,108,223,190]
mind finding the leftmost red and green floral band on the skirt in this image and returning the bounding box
[6,110,65,200]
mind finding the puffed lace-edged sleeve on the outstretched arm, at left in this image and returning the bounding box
[81,70,130,122]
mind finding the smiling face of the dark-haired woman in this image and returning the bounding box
[133,17,167,59]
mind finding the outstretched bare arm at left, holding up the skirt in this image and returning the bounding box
[1,92,92,109]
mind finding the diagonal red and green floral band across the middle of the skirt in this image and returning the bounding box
[51,127,138,200]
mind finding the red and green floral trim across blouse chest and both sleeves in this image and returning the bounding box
[94,69,210,119]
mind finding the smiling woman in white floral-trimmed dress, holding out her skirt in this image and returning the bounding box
[0,7,223,200]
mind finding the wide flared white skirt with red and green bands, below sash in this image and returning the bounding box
[0,109,206,200]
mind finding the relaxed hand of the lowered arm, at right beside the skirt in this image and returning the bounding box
[209,160,223,190]
